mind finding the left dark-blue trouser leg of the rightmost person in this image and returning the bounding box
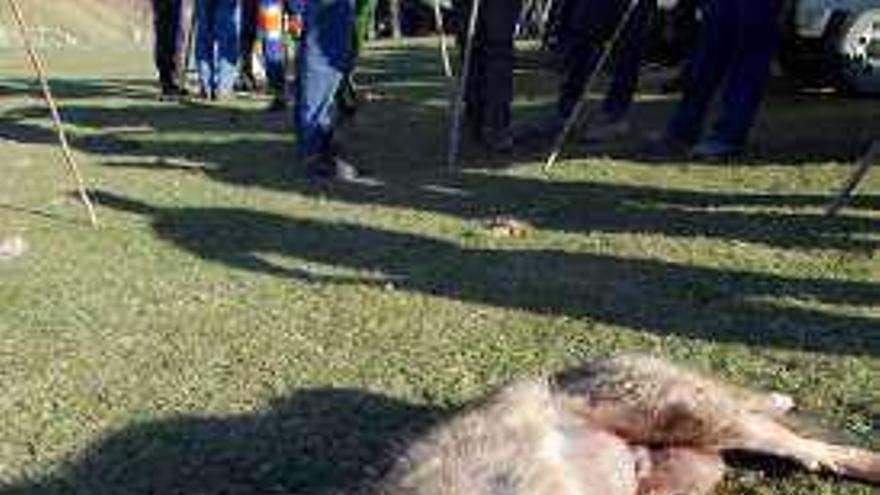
[666,0,736,142]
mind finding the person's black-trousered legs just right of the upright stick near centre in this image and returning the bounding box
[454,0,522,153]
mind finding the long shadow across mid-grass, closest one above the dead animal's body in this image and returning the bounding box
[96,192,880,356]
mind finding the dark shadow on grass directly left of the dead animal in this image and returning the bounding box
[0,388,444,495]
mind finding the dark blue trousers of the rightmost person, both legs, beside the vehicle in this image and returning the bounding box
[666,0,780,146]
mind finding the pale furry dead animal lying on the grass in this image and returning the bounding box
[370,355,880,495]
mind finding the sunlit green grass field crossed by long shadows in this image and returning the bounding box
[0,42,880,495]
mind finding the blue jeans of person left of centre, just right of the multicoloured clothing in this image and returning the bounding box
[294,0,355,157]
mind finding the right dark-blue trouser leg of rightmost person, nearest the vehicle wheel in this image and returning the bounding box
[712,0,778,146]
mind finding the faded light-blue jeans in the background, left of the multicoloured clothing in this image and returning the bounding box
[196,0,241,95]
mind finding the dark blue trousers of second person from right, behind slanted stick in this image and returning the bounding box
[557,0,657,120]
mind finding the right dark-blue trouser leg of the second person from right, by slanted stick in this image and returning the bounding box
[602,0,657,122]
